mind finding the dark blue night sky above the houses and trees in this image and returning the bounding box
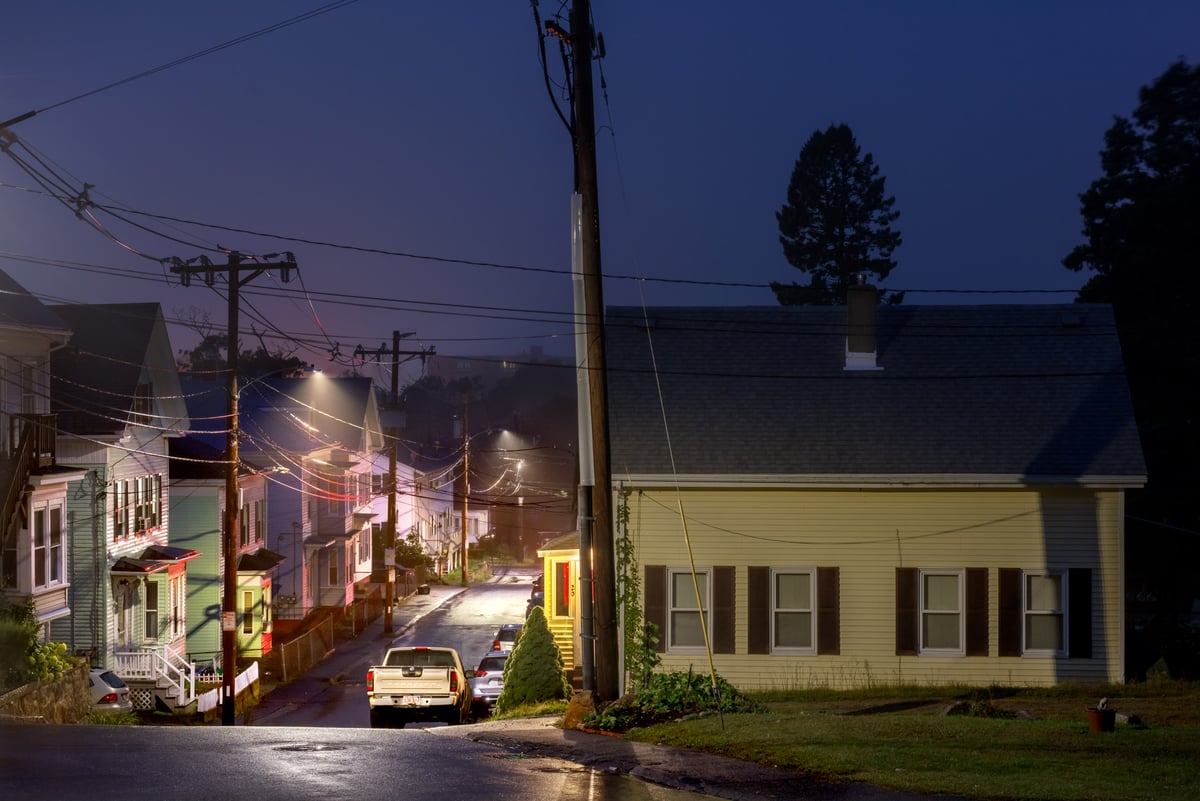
[0,0,1200,383]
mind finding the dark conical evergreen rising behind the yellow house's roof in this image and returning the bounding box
[770,124,904,306]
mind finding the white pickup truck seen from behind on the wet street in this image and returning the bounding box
[367,645,470,728]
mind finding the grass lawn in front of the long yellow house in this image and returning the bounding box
[625,681,1200,801]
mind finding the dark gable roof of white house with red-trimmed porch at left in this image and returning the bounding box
[50,303,187,435]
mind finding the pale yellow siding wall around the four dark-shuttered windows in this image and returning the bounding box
[625,484,1122,689]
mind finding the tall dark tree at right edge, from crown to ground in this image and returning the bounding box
[1063,61,1200,677]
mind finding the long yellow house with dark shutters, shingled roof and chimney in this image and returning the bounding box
[606,285,1145,689]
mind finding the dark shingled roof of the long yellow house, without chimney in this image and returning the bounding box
[606,303,1146,486]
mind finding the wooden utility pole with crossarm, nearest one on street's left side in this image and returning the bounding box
[170,251,296,725]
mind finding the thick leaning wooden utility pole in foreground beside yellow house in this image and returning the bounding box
[570,0,620,700]
